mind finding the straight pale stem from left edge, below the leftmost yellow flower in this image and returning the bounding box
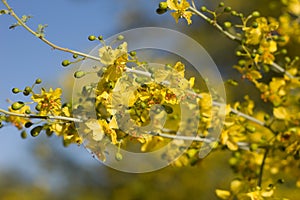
[0,108,82,122]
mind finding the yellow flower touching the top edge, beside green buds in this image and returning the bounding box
[167,0,193,24]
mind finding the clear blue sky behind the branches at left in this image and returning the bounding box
[0,0,165,173]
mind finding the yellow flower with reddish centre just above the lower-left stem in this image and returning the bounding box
[31,88,62,115]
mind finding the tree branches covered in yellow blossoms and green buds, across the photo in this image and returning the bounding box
[0,0,300,199]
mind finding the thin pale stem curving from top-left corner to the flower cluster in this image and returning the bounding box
[2,0,100,61]
